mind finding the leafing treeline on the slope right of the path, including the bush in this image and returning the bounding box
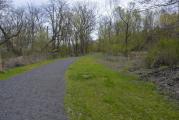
[96,0,179,67]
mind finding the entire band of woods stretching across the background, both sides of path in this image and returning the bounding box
[0,0,179,68]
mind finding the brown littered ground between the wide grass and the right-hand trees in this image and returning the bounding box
[97,53,179,101]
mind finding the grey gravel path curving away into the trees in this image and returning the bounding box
[0,58,75,120]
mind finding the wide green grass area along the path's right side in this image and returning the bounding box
[65,57,179,120]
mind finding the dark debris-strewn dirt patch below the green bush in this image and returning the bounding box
[133,67,179,100]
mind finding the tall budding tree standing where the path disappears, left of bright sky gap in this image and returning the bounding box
[73,3,95,54]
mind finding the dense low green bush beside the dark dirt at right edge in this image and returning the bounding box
[146,40,179,67]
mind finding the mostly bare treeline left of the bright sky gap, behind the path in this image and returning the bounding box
[0,0,96,58]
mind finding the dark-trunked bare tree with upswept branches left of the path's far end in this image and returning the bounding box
[45,0,67,51]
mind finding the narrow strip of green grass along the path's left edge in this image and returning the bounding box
[0,60,55,80]
